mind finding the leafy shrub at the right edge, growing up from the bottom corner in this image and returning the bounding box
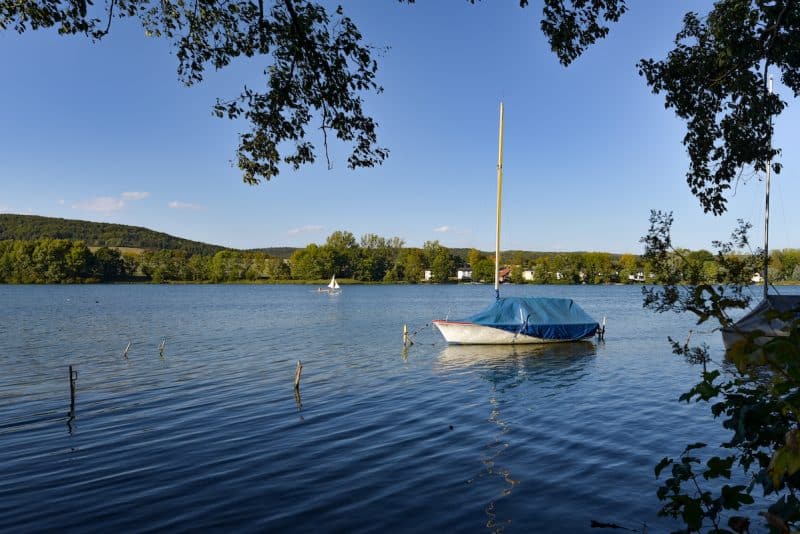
[643,212,800,533]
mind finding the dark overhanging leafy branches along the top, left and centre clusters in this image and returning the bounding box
[0,0,626,184]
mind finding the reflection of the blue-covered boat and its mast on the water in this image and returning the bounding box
[438,341,597,532]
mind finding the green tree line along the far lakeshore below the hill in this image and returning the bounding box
[0,231,800,284]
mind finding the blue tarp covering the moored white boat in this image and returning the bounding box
[459,297,600,341]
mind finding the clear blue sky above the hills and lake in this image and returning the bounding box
[0,0,800,253]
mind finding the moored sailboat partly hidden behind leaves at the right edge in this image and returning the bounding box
[722,76,800,350]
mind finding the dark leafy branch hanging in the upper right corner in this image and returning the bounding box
[639,0,800,215]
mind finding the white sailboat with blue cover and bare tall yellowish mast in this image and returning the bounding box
[432,102,600,345]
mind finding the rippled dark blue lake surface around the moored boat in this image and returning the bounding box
[0,285,797,532]
